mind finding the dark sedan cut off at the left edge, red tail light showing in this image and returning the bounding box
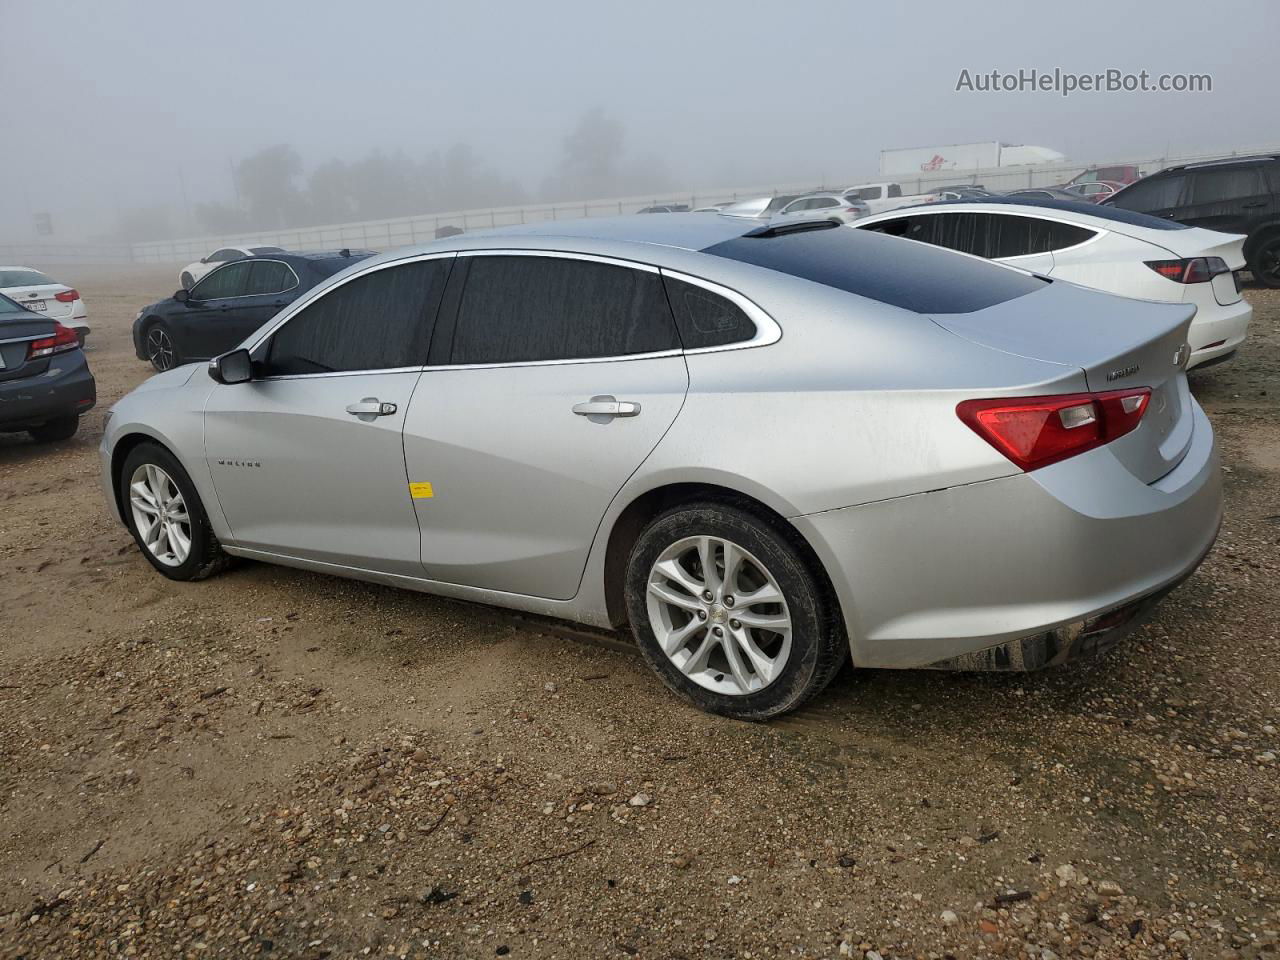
[0,294,97,442]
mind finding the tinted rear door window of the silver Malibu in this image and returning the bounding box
[452,256,680,364]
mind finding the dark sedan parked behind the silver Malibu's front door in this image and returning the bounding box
[133,250,372,370]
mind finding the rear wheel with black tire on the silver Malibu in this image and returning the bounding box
[626,502,849,721]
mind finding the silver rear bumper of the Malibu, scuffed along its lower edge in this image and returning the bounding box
[792,404,1222,669]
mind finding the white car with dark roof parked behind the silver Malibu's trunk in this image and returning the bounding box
[854,197,1253,367]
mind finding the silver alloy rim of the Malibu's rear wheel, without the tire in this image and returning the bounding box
[645,536,791,696]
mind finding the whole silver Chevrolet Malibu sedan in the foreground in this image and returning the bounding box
[101,214,1221,719]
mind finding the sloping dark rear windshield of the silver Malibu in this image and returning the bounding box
[703,227,1047,314]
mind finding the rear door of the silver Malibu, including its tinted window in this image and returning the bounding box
[404,251,689,600]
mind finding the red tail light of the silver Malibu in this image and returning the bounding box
[956,387,1151,471]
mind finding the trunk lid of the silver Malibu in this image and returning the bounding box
[932,282,1196,484]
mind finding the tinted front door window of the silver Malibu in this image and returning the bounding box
[268,257,453,375]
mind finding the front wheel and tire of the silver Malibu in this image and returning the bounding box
[116,443,230,580]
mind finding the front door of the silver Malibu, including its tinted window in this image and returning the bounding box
[205,255,453,577]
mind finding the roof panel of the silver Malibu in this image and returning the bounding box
[465,214,760,250]
